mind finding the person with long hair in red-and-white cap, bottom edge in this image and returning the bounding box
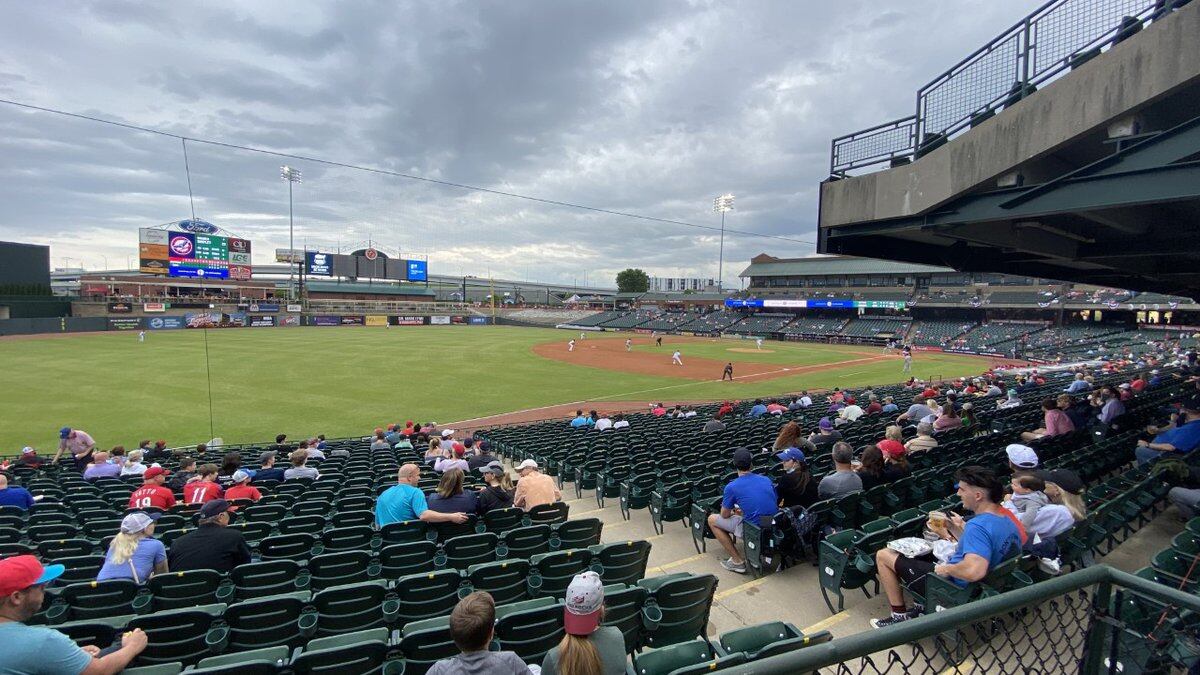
[541,572,626,675]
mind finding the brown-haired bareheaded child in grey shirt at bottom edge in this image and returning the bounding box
[428,591,529,675]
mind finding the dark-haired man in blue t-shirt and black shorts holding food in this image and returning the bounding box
[871,466,1021,628]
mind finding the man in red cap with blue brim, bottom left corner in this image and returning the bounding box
[0,555,146,675]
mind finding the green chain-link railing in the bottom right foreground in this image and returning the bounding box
[730,565,1200,675]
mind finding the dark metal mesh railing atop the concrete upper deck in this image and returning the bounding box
[829,0,1187,177]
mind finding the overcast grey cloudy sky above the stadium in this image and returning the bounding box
[0,0,1039,286]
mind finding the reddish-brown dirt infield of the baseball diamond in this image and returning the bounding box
[533,335,899,382]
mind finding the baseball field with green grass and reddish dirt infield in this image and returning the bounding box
[0,325,989,455]
